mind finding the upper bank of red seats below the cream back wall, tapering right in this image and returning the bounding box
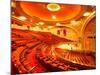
[12,29,71,45]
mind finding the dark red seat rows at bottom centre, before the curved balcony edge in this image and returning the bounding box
[37,51,78,71]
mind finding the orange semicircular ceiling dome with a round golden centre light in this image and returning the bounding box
[17,2,82,21]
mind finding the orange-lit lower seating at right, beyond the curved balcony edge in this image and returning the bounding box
[55,48,96,67]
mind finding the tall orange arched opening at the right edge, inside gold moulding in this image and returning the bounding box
[83,17,96,52]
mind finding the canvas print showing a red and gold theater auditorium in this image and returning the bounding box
[11,1,96,74]
